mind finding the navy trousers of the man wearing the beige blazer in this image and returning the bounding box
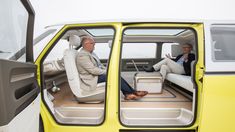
[98,74,135,95]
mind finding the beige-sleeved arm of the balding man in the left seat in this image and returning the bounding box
[76,55,106,75]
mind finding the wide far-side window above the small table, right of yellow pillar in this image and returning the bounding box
[122,43,157,59]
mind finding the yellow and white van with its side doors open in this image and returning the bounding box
[0,0,235,132]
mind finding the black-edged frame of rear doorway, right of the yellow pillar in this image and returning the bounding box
[118,23,199,128]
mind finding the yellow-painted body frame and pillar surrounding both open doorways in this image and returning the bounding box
[36,23,206,132]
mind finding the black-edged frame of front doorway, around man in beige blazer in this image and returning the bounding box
[37,24,117,127]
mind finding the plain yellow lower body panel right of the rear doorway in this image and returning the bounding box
[199,74,235,132]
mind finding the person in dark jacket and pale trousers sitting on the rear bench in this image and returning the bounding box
[145,43,195,80]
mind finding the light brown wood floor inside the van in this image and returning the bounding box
[50,83,192,110]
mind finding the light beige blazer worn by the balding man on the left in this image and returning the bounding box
[76,48,106,92]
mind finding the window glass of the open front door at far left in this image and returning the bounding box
[0,0,28,62]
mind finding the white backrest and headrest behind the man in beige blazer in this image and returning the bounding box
[64,35,82,97]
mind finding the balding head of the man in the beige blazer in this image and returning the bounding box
[81,36,95,52]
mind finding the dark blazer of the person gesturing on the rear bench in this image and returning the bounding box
[173,53,195,76]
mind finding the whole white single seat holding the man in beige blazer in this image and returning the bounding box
[64,35,105,102]
